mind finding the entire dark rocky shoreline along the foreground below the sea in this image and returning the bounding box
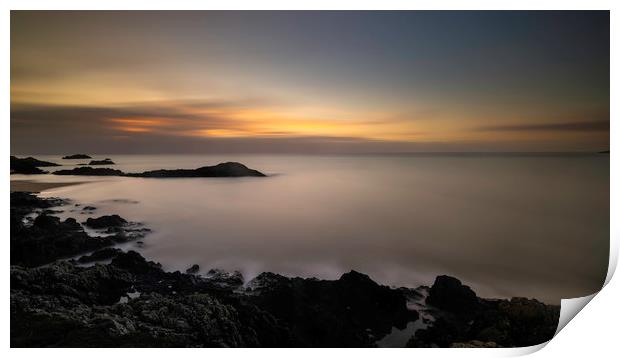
[11,192,559,347]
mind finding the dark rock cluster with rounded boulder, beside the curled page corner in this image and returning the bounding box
[407,276,560,347]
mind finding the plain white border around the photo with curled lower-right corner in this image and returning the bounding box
[0,0,620,357]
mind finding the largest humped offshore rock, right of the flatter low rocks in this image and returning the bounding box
[127,162,265,178]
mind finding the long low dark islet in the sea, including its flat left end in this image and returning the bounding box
[52,162,266,178]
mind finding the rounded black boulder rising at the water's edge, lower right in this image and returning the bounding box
[426,276,478,314]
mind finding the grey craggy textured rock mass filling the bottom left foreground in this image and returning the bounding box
[10,262,291,347]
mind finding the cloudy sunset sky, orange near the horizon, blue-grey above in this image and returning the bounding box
[11,11,610,154]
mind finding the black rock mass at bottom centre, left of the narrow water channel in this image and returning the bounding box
[248,271,418,347]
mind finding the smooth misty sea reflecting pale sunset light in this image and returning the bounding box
[11,155,609,303]
